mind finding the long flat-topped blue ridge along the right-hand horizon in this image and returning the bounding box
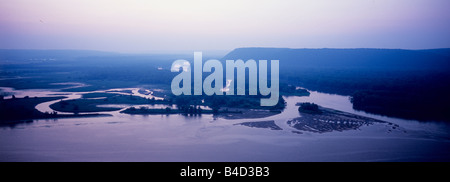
[222,48,450,70]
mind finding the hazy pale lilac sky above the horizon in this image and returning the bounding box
[0,0,450,52]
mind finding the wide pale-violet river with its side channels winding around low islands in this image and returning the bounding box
[0,87,450,161]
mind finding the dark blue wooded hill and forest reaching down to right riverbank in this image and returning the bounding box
[223,48,450,121]
